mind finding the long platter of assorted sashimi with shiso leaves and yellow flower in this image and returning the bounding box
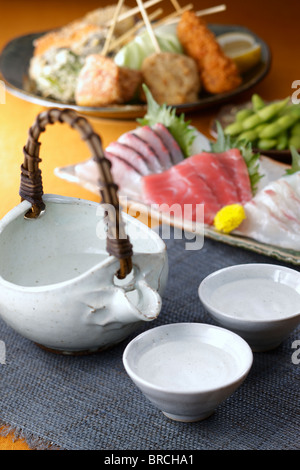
[55,86,300,265]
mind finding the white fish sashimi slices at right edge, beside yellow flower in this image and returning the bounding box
[235,173,300,251]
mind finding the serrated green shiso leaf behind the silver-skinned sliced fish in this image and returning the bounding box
[137,84,196,157]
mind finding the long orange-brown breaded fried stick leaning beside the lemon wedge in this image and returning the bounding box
[177,11,242,94]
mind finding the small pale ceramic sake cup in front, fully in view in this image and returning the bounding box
[123,323,253,422]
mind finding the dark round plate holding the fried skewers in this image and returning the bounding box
[0,24,271,119]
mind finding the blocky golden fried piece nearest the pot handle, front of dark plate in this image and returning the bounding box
[75,54,142,106]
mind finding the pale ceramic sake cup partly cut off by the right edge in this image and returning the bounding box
[199,263,300,352]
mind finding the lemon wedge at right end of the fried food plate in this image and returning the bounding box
[217,32,261,73]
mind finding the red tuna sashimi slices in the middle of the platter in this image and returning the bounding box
[142,151,252,225]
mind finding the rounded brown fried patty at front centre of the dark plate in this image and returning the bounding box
[141,52,200,105]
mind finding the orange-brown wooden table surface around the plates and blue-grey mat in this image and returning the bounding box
[0,0,300,450]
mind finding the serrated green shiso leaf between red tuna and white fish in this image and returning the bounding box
[211,122,263,194]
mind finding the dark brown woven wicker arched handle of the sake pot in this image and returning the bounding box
[19,108,133,278]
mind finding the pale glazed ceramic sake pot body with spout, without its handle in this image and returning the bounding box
[0,195,168,353]
